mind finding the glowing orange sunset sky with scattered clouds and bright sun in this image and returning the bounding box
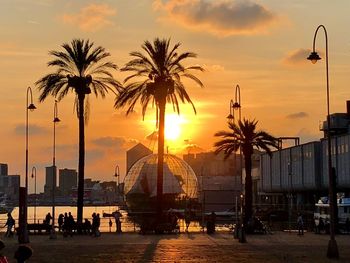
[0,0,350,192]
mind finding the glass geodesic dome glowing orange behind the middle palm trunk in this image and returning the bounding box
[124,154,198,198]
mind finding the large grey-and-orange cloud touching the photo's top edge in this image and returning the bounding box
[153,0,279,36]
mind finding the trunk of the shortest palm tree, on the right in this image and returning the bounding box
[244,153,253,224]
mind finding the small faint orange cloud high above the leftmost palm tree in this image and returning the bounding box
[62,4,116,32]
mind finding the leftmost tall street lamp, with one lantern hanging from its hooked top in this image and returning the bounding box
[19,87,36,243]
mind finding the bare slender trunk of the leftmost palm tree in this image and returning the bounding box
[77,94,85,224]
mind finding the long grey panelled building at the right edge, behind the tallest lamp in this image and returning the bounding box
[257,101,350,212]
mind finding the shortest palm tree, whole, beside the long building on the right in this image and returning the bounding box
[214,119,278,222]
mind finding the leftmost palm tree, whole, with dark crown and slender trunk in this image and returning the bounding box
[35,39,121,223]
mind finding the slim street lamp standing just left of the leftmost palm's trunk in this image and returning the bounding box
[50,100,61,239]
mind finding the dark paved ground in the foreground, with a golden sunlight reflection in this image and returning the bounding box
[3,232,350,263]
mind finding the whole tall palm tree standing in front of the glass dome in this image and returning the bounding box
[115,38,203,217]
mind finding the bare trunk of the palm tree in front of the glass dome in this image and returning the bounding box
[157,99,166,219]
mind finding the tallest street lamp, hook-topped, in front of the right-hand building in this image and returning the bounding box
[307,25,339,258]
